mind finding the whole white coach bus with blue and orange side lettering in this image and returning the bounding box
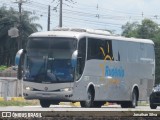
[15,29,155,108]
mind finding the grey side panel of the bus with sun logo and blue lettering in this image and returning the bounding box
[73,38,155,101]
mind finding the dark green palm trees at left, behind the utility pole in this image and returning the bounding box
[0,6,42,66]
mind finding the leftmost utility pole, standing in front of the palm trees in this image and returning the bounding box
[14,0,26,50]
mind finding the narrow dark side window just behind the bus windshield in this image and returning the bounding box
[77,38,86,80]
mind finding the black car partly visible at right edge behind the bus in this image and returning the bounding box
[149,84,160,109]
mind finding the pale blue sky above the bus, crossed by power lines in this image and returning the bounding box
[0,0,160,34]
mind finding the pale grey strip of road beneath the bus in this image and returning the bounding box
[0,105,160,111]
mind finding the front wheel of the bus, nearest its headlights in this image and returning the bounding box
[80,89,94,108]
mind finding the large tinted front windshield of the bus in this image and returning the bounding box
[24,37,77,83]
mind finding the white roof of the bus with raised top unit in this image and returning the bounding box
[30,28,154,44]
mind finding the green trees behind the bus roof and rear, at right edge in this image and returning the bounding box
[122,19,160,84]
